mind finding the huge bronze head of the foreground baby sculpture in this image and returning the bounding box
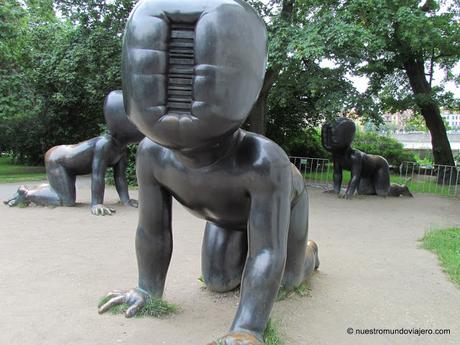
[123,0,267,149]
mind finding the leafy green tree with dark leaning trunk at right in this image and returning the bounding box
[298,0,460,165]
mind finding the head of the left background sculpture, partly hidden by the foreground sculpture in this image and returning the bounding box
[104,90,144,144]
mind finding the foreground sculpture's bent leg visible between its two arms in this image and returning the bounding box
[201,222,248,292]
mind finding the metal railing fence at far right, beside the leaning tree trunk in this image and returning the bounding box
[399,162,460,197]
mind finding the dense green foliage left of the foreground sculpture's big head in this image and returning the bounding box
[0,0,133,163]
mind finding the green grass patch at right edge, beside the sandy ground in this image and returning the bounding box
[422,228,460,285]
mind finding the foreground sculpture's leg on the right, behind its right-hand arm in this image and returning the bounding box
[281,190,319,291]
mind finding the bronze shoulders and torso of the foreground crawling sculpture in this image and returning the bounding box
[141,131,305,230]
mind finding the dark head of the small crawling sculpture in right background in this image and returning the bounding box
[321,117,356,152]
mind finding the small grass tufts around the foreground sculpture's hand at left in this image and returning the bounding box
[99,296,179,318]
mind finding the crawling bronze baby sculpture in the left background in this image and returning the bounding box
[5,91,144,215]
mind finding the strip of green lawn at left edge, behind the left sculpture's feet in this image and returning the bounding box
[0,156,46,183]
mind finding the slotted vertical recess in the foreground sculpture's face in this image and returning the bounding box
[167,23,195,114]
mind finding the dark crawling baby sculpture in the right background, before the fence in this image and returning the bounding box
[321,117,390,199]
